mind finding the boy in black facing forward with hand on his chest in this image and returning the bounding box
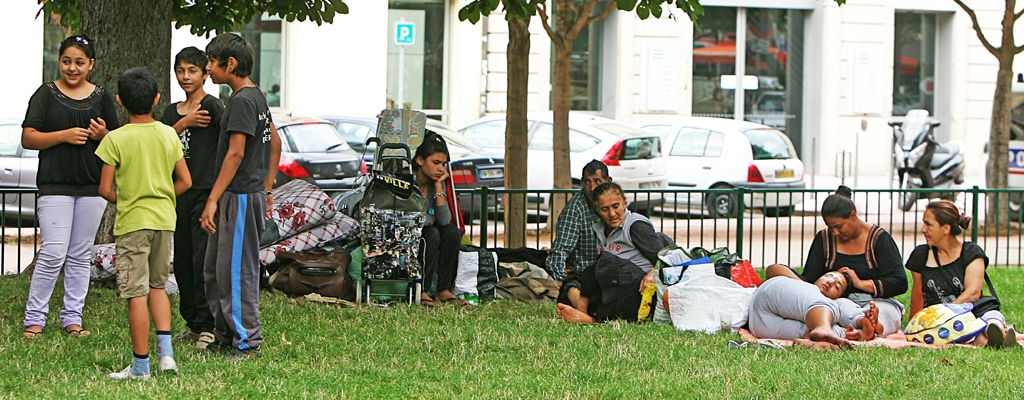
[160,47,224,350]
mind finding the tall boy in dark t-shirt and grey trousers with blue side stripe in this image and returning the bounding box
[200,34,281,360]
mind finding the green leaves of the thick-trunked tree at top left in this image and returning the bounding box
[40,0,348,36]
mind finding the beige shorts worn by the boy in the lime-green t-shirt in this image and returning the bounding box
[115,229,174,299]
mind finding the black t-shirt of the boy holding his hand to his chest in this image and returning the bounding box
[160,94,224,189]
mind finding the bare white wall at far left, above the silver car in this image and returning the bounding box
[0,0,43,119]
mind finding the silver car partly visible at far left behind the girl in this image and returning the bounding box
[0,120,39,219]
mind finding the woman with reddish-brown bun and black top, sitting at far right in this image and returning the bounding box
[906,201,1020,348]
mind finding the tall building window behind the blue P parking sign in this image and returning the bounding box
[387,0,446,115]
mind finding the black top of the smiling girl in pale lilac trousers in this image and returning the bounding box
[22,82,121,196]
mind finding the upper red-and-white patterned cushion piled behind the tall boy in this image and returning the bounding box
[259,179,337,247]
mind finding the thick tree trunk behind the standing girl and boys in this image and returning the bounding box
[82,0,173,243]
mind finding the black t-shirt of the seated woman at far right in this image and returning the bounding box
[906,241,988,307]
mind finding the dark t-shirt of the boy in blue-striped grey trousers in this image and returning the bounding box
[216,86,276,193]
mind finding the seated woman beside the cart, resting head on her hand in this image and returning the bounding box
[413,132,466,307]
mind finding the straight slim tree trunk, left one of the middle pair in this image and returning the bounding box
[505,16,529,249]
